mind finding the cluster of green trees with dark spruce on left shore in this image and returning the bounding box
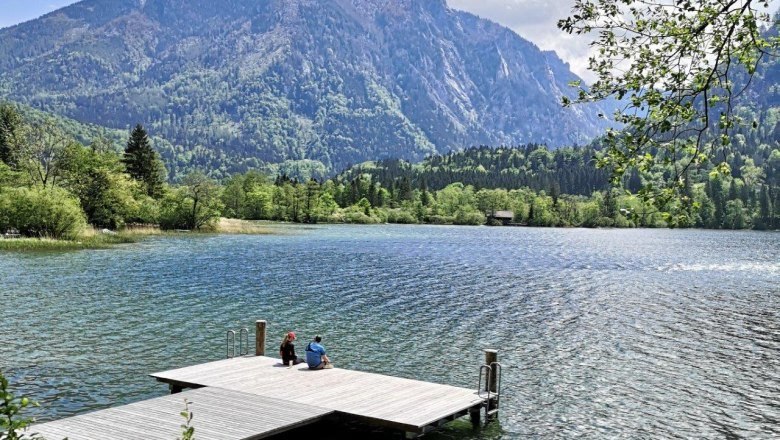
[0,105,221,239]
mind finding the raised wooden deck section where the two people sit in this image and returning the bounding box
[151,356,483,433]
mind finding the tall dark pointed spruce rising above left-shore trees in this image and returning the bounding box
[122,124,165,198]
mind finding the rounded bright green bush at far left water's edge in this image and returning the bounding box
[0,187,87,239]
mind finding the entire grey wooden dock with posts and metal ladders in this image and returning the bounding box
[27,320,500,440]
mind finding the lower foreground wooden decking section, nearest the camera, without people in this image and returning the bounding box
[27,388,333,440]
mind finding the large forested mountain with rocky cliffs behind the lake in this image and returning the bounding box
[0,0,611,174]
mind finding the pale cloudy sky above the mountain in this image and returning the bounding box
[0,0,780,82]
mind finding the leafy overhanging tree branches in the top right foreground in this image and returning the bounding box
[558,0,780,219]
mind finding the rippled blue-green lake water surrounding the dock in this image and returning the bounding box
[0,226,780,439]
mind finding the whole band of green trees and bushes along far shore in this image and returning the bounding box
[0,101,780,249]
